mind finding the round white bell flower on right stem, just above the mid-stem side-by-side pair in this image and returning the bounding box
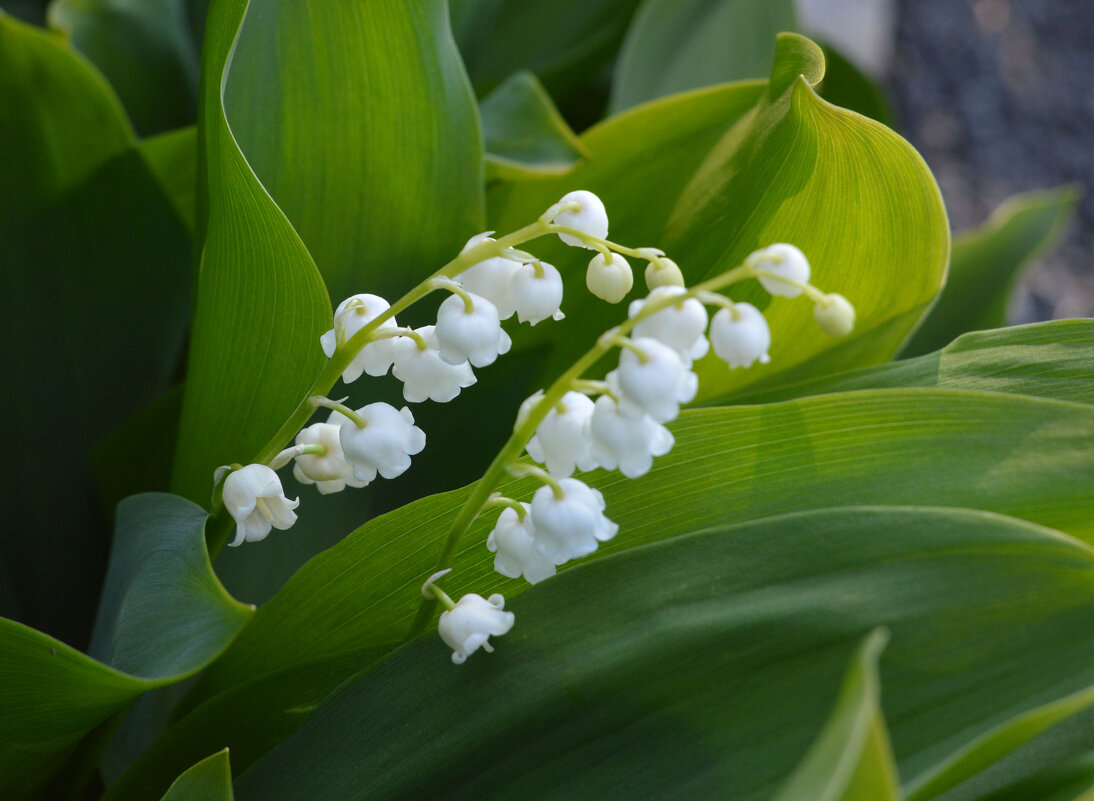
[607,337,699,422]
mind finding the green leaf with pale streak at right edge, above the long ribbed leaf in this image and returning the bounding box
[710,320,1094,404]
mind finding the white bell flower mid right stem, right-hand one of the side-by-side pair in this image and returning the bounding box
[589,395,676,478]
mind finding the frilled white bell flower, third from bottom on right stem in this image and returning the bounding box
[528,478,619,565]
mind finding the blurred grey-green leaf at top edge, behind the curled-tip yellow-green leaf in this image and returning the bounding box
[609,0,798,114]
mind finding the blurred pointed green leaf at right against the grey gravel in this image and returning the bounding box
[901,187,1079,357]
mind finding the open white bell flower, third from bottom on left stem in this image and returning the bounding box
[338,403,426,481]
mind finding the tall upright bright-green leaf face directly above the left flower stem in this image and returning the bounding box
[224,0,485,304]
